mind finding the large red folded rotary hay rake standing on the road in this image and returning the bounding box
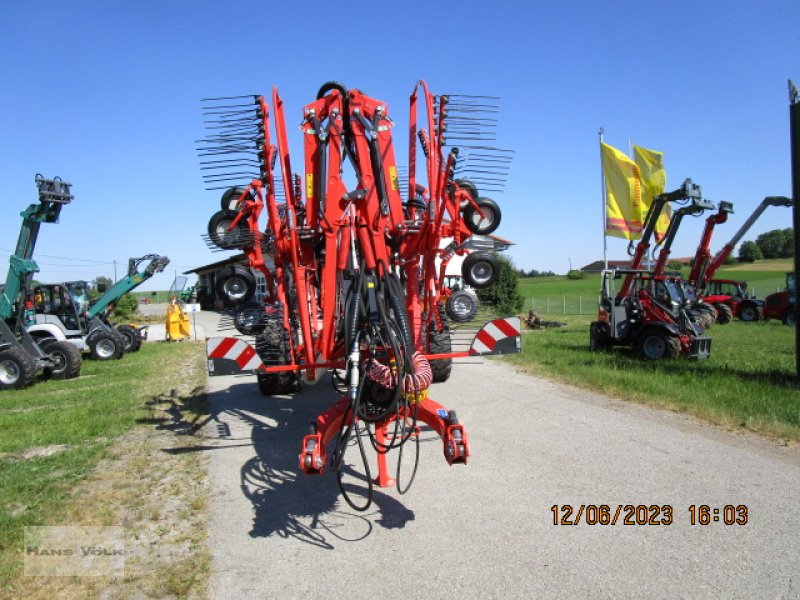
[200,81,520,510]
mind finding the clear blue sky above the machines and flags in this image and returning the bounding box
[0,0,800,289]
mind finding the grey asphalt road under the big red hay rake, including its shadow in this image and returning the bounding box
[205,350,800,599]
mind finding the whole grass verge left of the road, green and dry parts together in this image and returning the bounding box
[0,343,208,598]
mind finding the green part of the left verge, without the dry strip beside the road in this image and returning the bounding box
[0,342,204,591]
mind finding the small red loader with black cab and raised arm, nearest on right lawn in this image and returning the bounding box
[589,179,713,360]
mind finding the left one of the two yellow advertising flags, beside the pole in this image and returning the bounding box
[600,142,645,240]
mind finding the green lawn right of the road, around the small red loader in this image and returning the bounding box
[507,316,800,440]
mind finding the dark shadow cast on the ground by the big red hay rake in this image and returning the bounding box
[160,376,414,549]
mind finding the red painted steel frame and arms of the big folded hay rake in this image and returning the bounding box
[212,81,510,485]
